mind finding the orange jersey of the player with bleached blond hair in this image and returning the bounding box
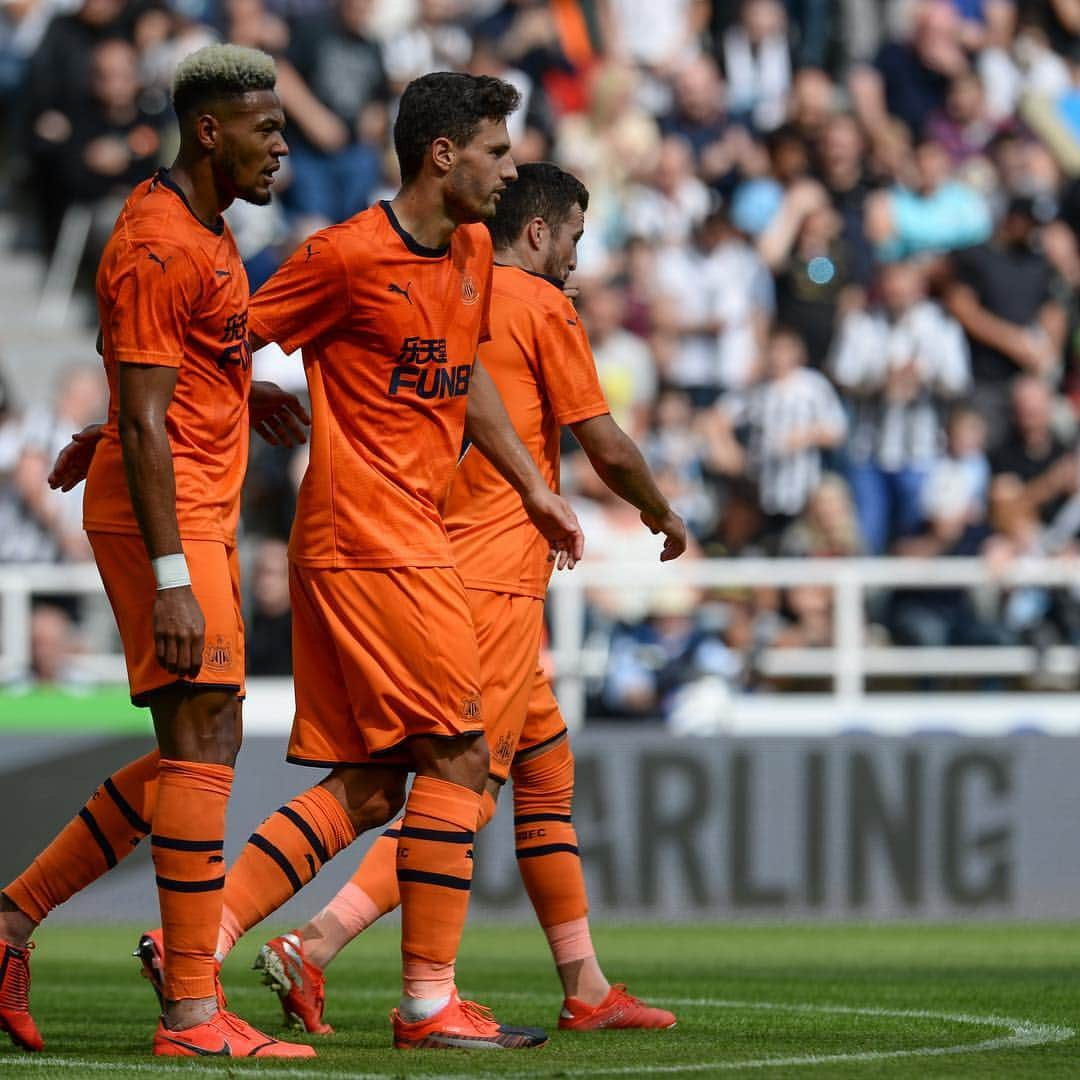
[83,170,252,544]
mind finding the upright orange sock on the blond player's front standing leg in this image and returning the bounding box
[150,758,232,1001]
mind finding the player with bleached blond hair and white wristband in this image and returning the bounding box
[0,46,314,1057]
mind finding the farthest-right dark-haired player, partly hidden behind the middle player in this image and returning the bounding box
[256,163,686,1034]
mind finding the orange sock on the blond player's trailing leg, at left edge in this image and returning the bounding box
[3,751,161,922]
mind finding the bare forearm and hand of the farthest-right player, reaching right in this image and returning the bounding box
[570,413,686,563]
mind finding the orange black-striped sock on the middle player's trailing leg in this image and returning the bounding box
[217,784,356,960]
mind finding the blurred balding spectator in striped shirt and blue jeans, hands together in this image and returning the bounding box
[832,262,971,555]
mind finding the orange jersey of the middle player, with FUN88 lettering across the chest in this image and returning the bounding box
[252,202,491,568]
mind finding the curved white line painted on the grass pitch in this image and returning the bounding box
[0,990,1076,1080]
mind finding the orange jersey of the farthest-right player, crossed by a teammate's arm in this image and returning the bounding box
[446,266,608,597]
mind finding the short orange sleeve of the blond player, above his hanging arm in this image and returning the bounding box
[108,242,202,367]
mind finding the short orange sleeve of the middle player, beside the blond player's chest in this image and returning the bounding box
[247,232,349,352]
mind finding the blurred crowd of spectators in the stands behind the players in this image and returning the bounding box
[0,0,1080,717]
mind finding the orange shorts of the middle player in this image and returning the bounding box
[287,563,484,768]
